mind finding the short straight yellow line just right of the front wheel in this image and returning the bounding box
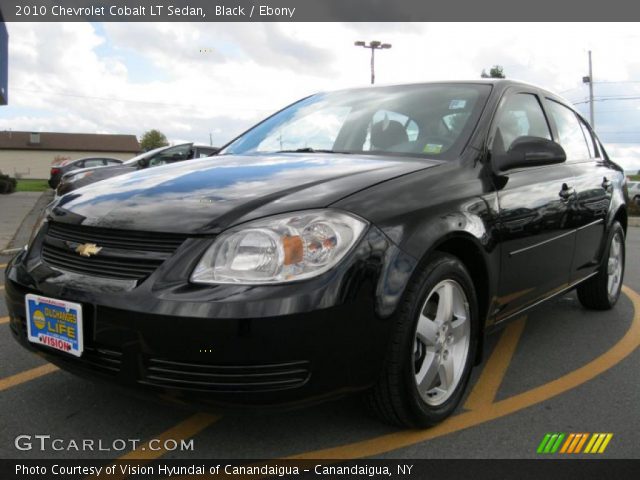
[464,317,527,410]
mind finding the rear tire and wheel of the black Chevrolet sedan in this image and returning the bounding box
[577,221,626,310]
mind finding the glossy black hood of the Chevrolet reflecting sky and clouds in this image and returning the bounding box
[52,153,441,234]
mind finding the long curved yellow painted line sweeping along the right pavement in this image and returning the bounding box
[284,286,640,460]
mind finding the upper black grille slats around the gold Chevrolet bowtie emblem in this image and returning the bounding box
[42,223,186,280]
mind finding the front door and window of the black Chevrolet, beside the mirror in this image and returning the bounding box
[490,89,575,321]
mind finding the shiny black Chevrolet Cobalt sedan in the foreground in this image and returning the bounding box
[6,80,627,427]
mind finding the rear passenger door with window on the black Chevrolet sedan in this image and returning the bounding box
[546,99,616,282]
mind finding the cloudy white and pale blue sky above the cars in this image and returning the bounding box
[0,23,640,170]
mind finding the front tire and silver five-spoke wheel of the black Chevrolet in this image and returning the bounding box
[365,253,479,428]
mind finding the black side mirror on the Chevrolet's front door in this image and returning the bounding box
[493,137,567,172]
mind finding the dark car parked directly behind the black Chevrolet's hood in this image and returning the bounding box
[56,143,220,196]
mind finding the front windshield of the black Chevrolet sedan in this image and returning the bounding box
[221,84,491,159]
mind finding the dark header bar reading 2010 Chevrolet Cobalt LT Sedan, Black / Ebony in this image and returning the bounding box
[0,0,640,21]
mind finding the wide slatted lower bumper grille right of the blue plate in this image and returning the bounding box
[141,358,310,393]
